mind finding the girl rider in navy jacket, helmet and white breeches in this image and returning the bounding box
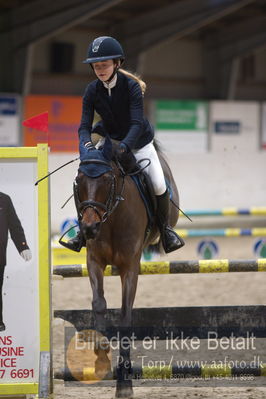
[65,36,184,253]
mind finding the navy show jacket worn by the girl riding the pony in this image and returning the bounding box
[79,72,154,150]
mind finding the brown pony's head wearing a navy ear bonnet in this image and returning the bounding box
[75,138,116,240]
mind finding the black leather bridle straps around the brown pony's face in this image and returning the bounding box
[74,159,125,224]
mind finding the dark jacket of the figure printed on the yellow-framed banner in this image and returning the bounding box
[0,192,29,267]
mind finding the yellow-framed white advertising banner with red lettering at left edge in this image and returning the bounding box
[0,145,50,397]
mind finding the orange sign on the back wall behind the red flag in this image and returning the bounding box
[23,95,82,152]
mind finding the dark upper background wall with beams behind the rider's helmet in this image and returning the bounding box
[0,0,266,100]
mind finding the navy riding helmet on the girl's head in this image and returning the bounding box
[83,36,125,64]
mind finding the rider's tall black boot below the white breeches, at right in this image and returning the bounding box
[156,190,185,253]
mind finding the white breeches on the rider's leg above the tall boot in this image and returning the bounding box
[132,143,166,195]
